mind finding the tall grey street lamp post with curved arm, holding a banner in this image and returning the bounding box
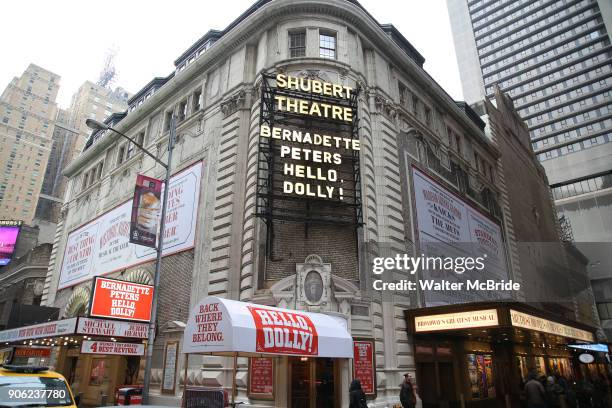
[85,115,176,404]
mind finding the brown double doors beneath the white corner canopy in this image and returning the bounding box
[289,357,339,408]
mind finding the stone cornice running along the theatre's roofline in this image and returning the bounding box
[63,0,497,177]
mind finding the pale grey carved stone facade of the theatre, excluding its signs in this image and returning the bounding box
[43,0,524,407]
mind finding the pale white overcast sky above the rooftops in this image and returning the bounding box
[0,0,463,108]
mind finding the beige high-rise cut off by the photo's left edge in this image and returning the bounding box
[0,64,60,223]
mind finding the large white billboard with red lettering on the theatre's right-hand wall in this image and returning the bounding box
[412,167,508,306]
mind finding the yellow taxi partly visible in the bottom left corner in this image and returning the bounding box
[0,364,77,408]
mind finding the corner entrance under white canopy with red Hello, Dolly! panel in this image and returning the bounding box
[183,297,354,408]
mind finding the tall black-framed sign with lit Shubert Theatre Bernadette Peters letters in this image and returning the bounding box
[258,74,361,224]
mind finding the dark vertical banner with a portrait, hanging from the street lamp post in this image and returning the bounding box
[130,174,162,248]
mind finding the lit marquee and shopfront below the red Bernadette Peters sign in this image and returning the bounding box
[0,317,148,405]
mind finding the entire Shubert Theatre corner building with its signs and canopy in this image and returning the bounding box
[22,0,604,407]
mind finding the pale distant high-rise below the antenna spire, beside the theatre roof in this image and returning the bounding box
[68,81,130,156]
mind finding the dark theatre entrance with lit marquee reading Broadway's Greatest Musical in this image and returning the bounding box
[406,302,598,408]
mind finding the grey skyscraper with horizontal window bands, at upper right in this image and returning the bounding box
[447,0,612,336]
